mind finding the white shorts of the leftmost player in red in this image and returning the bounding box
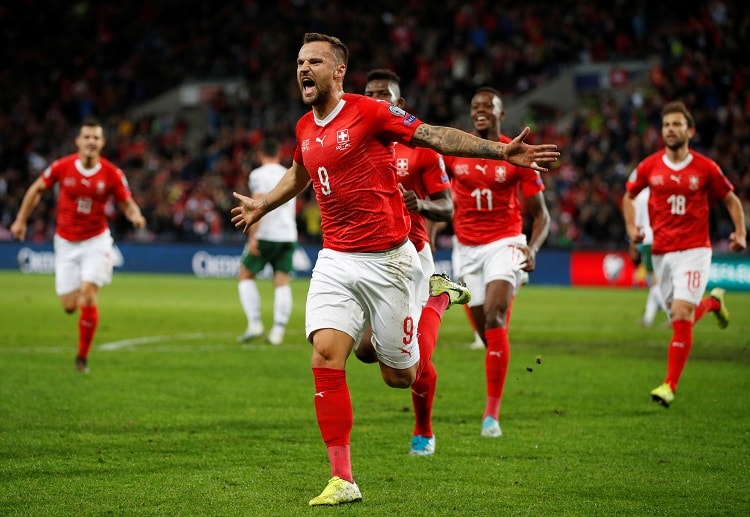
[54,230,114,296]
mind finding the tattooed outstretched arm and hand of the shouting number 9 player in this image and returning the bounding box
[410,124,560,172]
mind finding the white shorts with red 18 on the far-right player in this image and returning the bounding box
[651,248,712,307]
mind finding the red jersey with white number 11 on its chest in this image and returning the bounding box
[444,135,544,246]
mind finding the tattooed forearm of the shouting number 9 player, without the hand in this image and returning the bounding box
[411,124,505,160]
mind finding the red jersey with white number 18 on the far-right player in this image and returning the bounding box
[626,151,734,255]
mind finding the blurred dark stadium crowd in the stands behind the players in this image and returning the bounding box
[0,0,750,249]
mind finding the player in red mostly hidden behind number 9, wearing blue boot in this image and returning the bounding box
[362,69,453,456]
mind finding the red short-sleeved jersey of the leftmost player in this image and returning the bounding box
[42,154,131,241]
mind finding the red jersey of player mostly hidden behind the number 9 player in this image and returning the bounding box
[395,144,451,250]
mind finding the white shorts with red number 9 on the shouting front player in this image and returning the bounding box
[305,240,424,370]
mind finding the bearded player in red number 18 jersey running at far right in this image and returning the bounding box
[622,101,747,407]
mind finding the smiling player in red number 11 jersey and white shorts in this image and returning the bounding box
[445,87,550,438]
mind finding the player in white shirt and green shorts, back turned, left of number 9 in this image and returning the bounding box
[237,138,297,345]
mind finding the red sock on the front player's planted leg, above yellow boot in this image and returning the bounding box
[312,368,354,482]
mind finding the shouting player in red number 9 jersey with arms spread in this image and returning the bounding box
[232,33,559,506]
